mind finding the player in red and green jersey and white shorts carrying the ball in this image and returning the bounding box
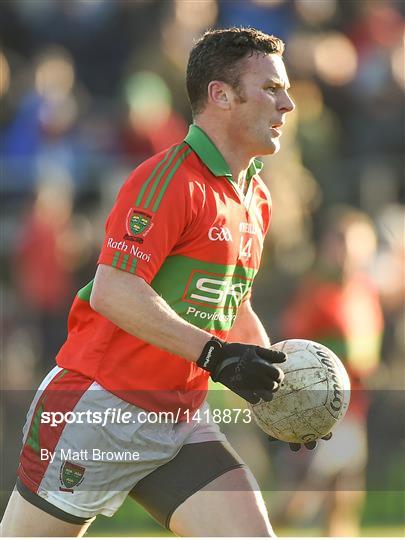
[2,28,294,537]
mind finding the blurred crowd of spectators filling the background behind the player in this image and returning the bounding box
[0,0,405,535]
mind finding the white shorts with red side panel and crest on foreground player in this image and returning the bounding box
[18,367,226,518]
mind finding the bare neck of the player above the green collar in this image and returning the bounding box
[194,116,254,190]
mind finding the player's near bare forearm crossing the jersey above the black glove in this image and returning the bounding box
[90,264,212,362]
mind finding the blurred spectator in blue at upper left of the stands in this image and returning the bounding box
[0,45,88,196]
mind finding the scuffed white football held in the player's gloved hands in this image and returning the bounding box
[249,339,350,443]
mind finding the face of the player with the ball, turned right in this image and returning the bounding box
[229,54,295,156]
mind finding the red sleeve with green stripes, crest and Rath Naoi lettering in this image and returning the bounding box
[98,148,191,284]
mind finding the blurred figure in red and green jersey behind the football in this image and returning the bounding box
[276,207,383,536]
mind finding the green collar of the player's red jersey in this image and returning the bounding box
[184,124,263,181]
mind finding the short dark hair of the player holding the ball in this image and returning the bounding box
[186,28,284,116]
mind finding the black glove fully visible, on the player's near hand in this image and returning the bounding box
[197,338,287,403]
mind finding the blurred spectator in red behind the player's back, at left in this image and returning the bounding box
[13,170,84,371]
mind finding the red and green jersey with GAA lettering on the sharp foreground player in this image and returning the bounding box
[57,125,271,410]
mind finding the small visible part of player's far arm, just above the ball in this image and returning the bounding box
[228,300,270,348]
